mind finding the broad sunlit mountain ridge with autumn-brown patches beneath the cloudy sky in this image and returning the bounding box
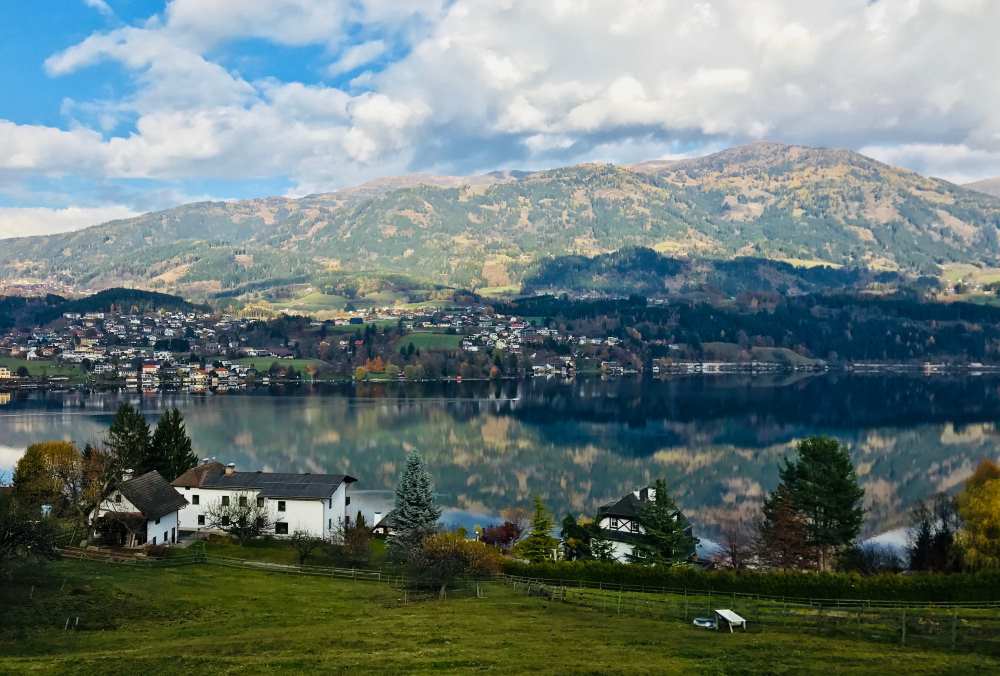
[0,143,1000,297]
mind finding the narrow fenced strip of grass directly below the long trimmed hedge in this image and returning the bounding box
[504,576,1000,655]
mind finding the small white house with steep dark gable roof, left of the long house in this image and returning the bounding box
[94,470,188,546]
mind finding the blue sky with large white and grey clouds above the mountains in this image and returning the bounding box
[0,0,1000,237]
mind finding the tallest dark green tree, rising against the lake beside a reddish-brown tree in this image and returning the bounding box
[779,437,865,570]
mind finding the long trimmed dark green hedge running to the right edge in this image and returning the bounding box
[504,560,1000,602]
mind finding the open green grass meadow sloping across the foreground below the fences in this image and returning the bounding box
[0,561,1000,674]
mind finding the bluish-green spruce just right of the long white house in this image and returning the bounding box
[389,451,441,559]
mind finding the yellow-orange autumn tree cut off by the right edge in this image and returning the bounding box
[958,460,1000,569]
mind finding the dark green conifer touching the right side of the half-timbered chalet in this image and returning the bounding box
[629,479,698,565]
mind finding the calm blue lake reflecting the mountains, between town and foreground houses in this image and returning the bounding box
[0,374,1000,537]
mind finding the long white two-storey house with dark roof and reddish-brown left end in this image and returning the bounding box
[172,461,356,539]
